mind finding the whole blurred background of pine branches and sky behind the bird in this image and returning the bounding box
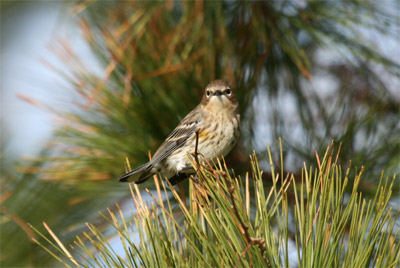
[0,0,400,267]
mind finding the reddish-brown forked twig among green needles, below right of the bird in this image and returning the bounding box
[229,186,271,267]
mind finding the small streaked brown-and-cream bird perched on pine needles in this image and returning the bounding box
[119,80,240,185]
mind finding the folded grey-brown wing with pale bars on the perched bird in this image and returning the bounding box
[152,106,202,164]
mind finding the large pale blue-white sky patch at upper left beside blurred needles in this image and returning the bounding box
[0,2,99,158]
